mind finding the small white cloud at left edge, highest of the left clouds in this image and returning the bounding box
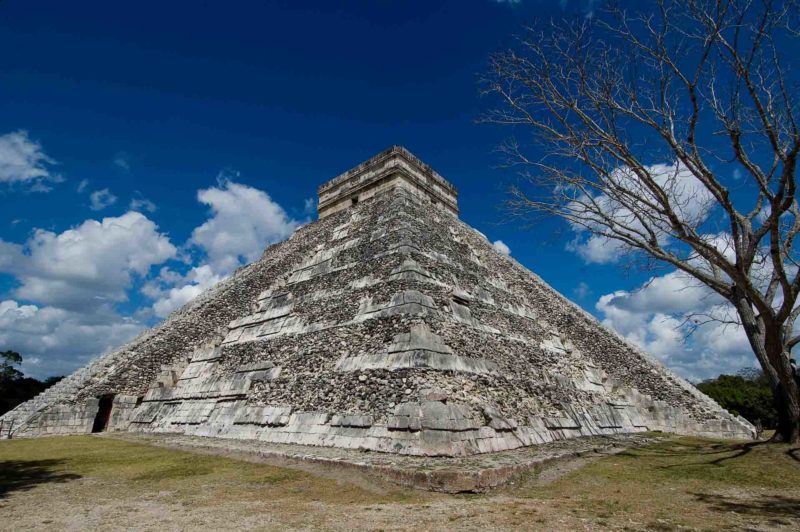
[0,130,63,192]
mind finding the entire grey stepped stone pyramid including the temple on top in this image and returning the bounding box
[0,147,753,456]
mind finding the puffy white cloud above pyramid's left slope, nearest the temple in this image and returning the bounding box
[189,180,300,275]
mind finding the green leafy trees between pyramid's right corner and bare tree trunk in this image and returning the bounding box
[697,368,778,429]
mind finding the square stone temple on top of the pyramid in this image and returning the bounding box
[317,146,458,219]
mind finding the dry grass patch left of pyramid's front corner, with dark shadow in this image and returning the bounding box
[0,436,421,528]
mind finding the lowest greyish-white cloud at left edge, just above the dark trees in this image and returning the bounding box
[0,300,143,378]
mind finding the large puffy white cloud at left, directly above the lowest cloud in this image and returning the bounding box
[0,212,176,312]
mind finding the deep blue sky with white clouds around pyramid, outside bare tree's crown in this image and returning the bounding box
[0,0,764,378]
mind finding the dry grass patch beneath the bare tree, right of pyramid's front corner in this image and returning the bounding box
[506,438,800,530]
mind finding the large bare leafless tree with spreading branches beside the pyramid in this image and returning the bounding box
[483,0,800,442]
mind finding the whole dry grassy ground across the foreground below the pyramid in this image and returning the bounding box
[0,436,800,530]
